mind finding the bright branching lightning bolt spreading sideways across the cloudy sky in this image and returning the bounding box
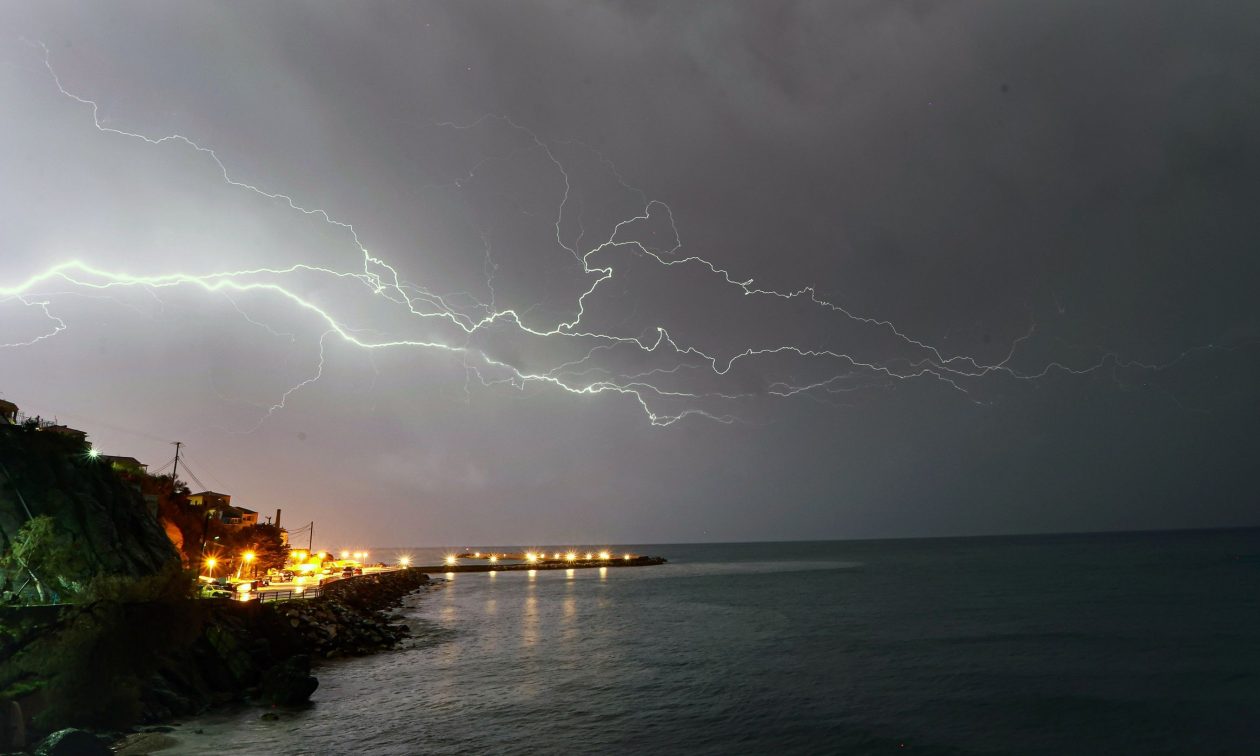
[0,43,1212,432]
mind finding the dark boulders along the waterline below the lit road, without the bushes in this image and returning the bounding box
[0,570,430,753]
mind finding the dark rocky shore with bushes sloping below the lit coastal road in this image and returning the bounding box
[0,570,430,750]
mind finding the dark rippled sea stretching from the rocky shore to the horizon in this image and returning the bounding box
[178,530,1260,755]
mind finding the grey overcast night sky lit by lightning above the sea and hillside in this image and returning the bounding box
[0,1,1260,548]
